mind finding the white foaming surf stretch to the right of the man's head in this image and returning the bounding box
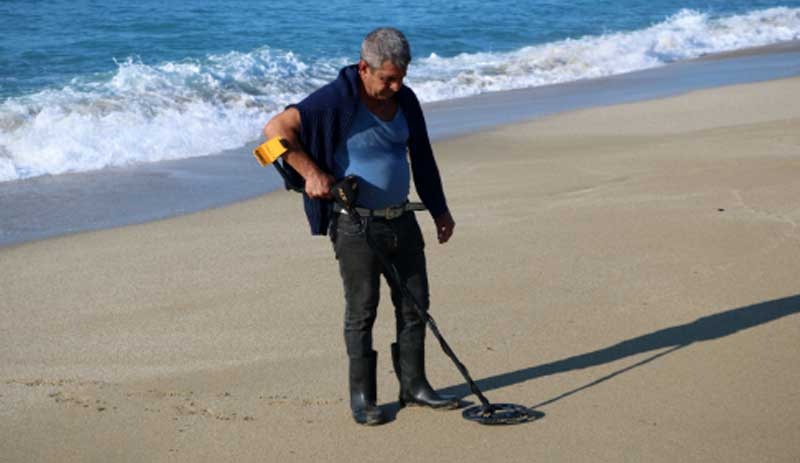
[409,8,800,101]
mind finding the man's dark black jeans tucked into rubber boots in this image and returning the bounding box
[331,212,430,358]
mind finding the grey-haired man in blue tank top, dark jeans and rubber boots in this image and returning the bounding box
[264,28,458,425]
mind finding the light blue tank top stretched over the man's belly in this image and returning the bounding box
[334,102,411,209]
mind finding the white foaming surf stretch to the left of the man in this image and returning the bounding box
[0,48,342,181]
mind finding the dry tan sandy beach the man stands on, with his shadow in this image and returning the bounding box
[0,78,800,463]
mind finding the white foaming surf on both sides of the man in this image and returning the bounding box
[0,8,800,181]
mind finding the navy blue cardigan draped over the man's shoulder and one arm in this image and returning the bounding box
[284,65,447,235]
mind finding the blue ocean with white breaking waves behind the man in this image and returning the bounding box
[0,0,800,182]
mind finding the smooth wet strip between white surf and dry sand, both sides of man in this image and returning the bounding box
[0,41,800,248]
